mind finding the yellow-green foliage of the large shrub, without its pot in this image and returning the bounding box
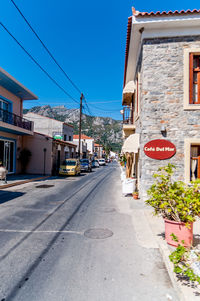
[146,163,200,224]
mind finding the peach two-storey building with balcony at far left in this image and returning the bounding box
[0,68,37,174]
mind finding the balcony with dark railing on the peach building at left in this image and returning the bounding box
[0,109,33,134]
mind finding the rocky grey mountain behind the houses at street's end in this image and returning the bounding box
[24,105,122,151]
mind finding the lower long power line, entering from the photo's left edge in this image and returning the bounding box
[0,22,79,103]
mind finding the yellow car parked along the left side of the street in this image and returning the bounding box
[59,159,81,176]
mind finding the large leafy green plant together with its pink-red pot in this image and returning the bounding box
[146,163,200,247]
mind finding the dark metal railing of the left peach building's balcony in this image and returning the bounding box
[0,109,33,131]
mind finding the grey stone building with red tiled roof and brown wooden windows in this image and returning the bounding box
[123,8,200,198]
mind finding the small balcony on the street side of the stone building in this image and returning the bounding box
[123,106,135,138]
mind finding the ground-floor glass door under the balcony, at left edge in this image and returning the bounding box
[0,139,15,173]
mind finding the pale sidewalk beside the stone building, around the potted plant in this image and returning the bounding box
[124,196,200,301]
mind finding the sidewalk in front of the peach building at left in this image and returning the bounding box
[0,174,50,190]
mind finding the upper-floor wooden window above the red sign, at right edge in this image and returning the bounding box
[189,53,200,104]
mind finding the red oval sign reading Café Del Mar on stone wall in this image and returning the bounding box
[144,139,176,160]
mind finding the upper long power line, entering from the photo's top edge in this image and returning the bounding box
[11,0,82,94]
